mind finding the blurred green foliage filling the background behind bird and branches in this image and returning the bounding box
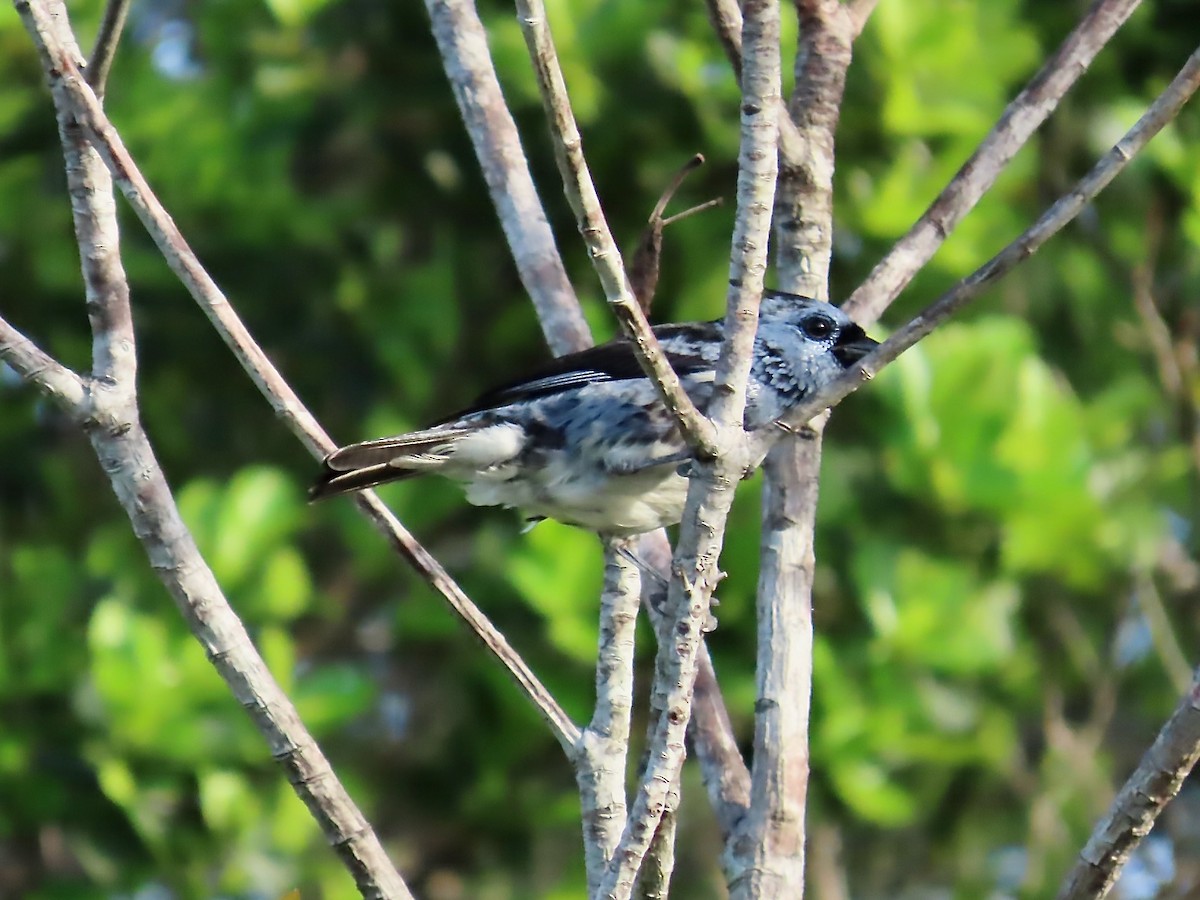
[0,0,1200,900]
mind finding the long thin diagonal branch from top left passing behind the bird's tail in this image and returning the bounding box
[18,0,578,752]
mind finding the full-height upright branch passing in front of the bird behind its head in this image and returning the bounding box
[600,0,780,900]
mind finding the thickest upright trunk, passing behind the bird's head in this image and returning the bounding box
[725,0,856,900]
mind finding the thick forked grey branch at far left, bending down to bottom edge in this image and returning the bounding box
[13,0,412,898]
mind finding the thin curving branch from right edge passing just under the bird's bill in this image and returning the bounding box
[763,43,1200,443]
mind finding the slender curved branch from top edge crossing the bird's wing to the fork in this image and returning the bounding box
[516,0,716,458]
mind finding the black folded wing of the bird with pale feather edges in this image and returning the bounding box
[453,322,721,421]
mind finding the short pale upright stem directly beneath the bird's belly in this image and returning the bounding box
[575,540,642,898]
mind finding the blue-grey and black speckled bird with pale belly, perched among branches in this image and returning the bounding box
[310,292,876,536]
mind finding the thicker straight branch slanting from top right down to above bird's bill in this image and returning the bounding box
[845,0,1141,325]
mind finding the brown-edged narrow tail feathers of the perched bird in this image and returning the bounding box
[308,428,470,500]
